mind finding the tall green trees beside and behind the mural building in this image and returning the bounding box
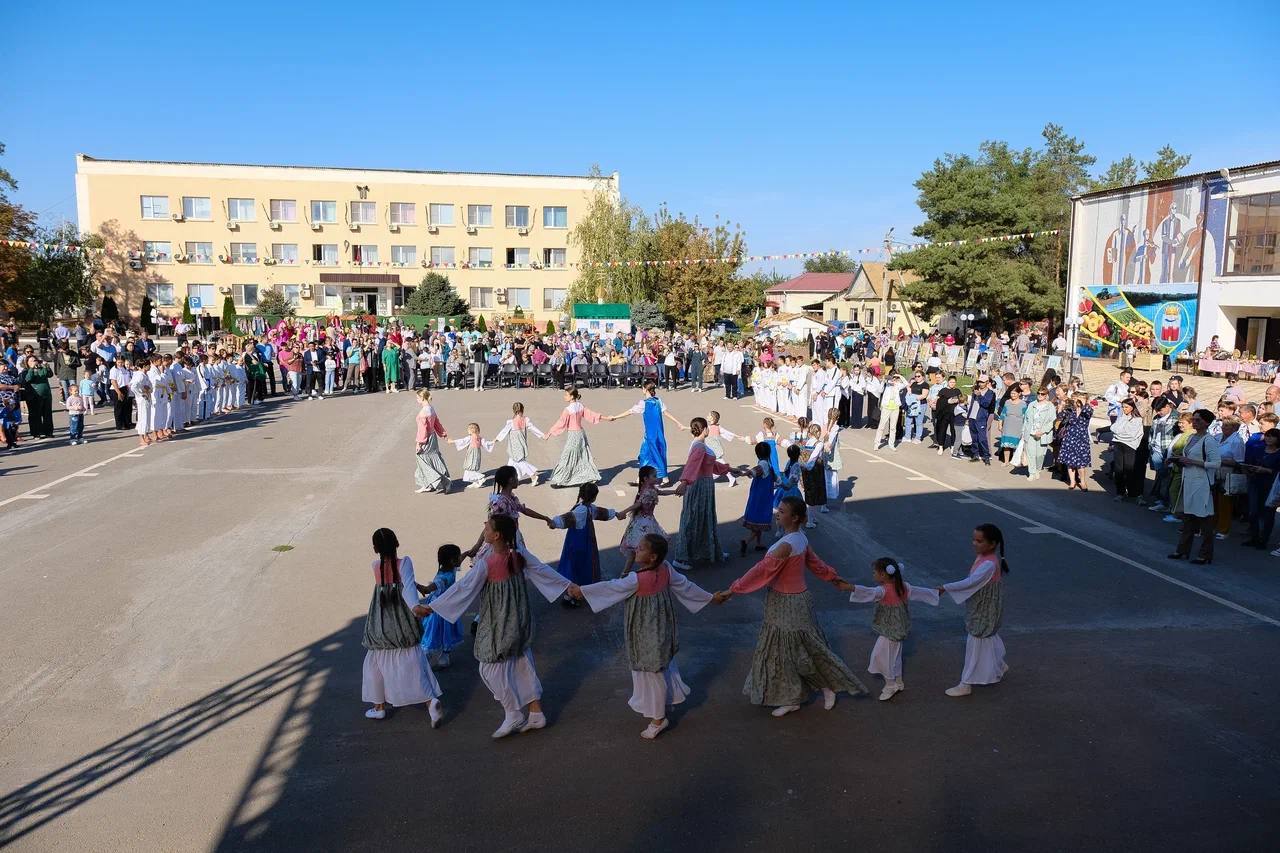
[891,124,1190,325]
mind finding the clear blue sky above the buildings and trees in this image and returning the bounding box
[0,0,1280,273]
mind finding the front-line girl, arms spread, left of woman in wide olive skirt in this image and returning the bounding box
[570,533,712,740]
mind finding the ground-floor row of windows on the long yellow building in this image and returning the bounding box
[147,282,568,313]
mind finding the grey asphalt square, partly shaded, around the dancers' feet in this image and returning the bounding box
[0,389,1280,850]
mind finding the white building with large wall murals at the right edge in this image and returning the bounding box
[1066,161,1280,359]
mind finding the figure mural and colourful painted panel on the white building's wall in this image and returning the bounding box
[1071,178,1226,356]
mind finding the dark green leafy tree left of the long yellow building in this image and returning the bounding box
[14,225,101,323]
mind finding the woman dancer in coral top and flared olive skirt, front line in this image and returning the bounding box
[714,497,867,717]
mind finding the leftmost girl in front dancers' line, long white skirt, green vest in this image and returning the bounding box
[361,528,444,729]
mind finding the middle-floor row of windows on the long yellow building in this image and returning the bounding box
[142,240,567,269]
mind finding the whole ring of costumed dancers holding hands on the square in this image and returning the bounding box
[362,384,1009,740]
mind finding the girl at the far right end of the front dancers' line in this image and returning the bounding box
[938,524,1009,695]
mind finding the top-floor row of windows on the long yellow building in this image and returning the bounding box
[141,196,568,228]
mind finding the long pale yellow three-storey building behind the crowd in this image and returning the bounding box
[76,154,618,324]
